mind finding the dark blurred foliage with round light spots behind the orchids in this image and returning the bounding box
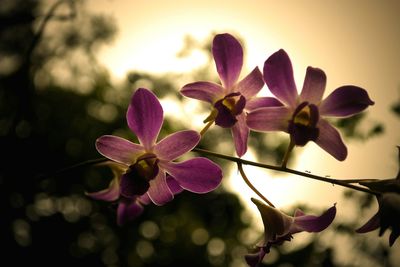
[0,0,395,267]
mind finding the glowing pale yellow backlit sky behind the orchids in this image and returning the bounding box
[88,0,400,231]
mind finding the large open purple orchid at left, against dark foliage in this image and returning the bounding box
[96,88,222,208]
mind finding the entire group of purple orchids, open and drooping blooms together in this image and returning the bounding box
[83,33,400,266]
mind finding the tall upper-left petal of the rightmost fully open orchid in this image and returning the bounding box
[263,49,298,107]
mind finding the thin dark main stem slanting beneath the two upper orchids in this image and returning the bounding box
[193,148,379,195]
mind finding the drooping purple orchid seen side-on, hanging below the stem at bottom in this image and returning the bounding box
[245,198,336,267]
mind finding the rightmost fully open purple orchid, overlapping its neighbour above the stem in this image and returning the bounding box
[247,49,374,161]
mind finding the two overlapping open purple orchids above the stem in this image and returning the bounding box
[181,34,374,160]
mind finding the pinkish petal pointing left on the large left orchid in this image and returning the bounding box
[96,135,144,166]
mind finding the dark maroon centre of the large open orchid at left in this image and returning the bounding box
[125,153,159,195]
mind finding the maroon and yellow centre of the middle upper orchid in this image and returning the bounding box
[214,93,246,128]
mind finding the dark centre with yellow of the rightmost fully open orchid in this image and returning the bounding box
[288,102,319,146]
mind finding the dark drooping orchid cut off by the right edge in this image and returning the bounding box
[356,147,400,246]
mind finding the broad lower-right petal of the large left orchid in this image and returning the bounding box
[160,157,222,193]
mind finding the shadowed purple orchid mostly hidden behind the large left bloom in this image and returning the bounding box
[86,161,183,225]
